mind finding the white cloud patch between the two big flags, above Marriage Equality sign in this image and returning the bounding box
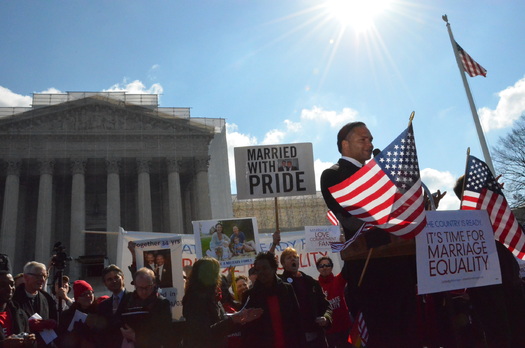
[421,168,459,210]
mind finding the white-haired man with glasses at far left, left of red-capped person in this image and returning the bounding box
[13,261,58,347]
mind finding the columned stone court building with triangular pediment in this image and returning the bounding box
[0,92,233,279]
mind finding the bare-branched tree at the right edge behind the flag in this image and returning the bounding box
[493,114,525,208]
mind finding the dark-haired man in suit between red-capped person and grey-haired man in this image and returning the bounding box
[98,265,128,348]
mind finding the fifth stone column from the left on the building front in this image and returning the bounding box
[137,158,153,232]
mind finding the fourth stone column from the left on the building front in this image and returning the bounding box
[106,158,120,264]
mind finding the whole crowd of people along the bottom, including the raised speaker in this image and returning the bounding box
[0,122,525,348]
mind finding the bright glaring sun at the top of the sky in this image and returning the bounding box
[326,0,392,32]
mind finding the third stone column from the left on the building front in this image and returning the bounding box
[69,158,87,279]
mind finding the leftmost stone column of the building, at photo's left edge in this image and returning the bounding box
[0,160,21,256]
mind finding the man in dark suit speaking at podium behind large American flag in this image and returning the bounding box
[321,122,417,348]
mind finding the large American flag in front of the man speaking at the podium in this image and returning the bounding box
[329,123,426,238]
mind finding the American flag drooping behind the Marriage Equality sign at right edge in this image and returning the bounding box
[461,156,525,260]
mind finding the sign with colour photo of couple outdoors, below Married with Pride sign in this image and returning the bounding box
[192,218,259,267]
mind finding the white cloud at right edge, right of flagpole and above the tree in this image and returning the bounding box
[478,77,525,132]
